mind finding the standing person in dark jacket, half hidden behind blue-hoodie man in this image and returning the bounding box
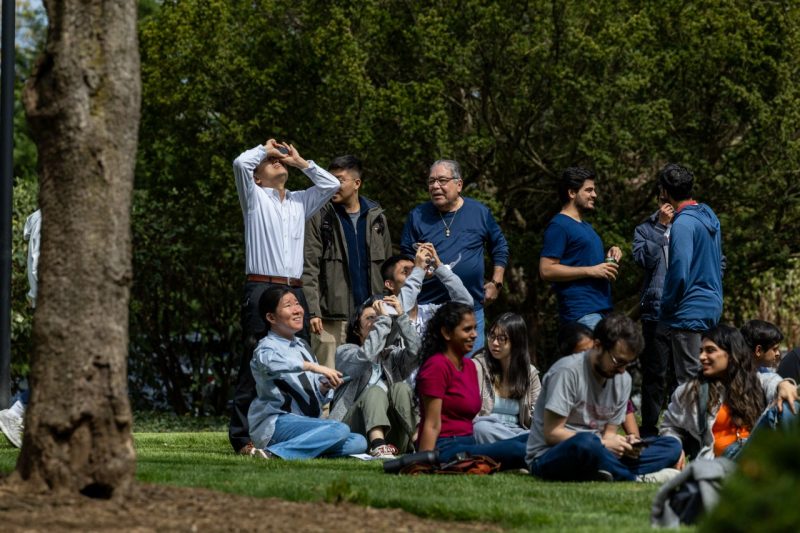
[633,202,675,437]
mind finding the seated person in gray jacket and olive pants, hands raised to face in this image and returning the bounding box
[330,296,419,459]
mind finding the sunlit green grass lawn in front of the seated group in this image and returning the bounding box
[0,424,692,533]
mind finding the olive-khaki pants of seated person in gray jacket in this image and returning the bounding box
[342,381,418,453]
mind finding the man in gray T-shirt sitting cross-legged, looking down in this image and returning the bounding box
[526,313,681,481]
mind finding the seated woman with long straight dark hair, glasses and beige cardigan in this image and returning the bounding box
[472,313,542,444]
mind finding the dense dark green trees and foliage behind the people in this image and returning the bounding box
[9,0,800,413]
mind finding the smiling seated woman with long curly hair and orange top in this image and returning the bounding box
[661,324,798,458]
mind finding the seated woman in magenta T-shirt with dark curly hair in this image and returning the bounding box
[416,302,527,470]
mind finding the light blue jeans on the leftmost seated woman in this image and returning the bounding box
[267,414,367,459]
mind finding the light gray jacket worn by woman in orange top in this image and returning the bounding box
[660,373,792,459]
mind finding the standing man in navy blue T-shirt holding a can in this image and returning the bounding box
[539,167,622,329]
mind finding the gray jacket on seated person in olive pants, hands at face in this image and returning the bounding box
[330,313,420,420]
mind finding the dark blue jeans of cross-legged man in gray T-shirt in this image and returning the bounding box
[531,431,681,481]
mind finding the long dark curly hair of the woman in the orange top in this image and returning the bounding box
[686,324,767,429]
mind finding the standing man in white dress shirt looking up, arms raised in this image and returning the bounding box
[228,139,340,454]
